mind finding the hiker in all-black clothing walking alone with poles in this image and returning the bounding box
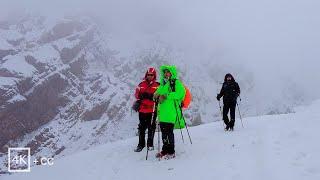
[217,74,240,131]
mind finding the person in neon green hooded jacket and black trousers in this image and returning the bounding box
[154,66,186,158]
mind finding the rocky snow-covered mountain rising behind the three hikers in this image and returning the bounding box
[0,15,316,172]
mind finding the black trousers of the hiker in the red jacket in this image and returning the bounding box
[138,112,157,147]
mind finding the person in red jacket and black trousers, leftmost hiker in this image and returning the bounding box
[134,68,160,152]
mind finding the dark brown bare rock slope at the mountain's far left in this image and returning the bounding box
[0,74,68,146]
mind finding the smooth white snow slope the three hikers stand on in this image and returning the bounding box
[3,101,320,180]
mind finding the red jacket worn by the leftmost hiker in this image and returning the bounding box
[135,68,160,113]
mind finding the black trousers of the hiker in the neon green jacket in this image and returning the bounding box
[160,122,175,154]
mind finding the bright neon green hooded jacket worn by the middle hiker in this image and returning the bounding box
[155,65,186,129]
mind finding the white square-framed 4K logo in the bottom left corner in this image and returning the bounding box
[8,148,30,172]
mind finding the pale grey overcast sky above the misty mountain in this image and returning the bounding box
[0,0,320,100]
